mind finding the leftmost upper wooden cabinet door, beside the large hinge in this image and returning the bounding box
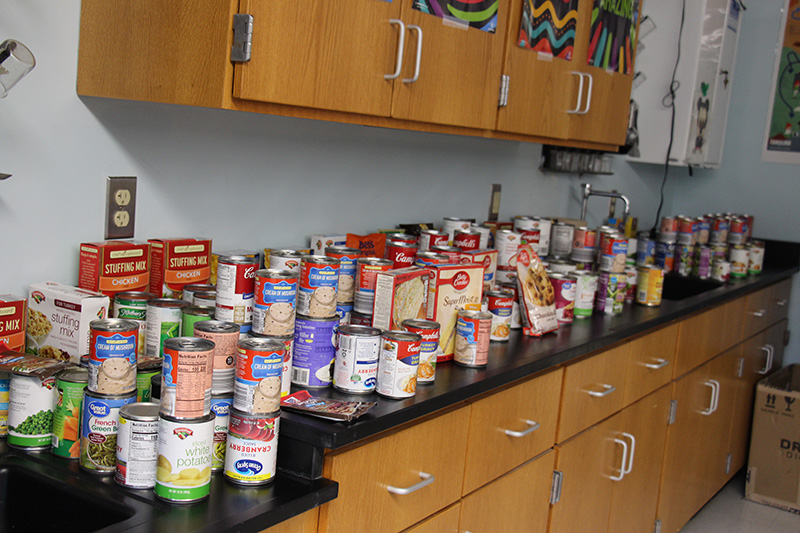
[233,0,409,116]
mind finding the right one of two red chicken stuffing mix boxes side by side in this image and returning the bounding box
[148,238,211,298]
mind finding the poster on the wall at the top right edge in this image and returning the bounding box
[761,0,800,164]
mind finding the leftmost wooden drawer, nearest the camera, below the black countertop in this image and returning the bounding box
[319,407,469,532]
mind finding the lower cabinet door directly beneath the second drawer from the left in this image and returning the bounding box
[459,451,555,533]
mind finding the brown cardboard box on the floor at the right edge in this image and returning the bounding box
[745,365,800,513]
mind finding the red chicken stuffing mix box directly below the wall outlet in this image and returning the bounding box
[78,241,150,297]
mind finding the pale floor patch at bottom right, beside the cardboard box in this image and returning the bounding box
[681,471,800,533]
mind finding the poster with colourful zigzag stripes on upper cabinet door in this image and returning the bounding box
[517,0,578,61]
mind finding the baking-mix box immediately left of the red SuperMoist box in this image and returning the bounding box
[372,267,431,330]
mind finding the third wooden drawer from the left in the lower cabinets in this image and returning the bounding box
[556,344,629,442]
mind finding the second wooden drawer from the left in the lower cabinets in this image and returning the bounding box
[462,369,563,494]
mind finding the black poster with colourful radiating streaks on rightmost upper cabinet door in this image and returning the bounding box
[588,0,639,74]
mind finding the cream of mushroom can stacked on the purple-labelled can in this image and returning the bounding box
[297,255,340,318]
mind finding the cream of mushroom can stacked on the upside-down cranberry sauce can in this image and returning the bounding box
[233,337,286,415]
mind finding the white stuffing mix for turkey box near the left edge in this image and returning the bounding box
[26,281,109,364]
